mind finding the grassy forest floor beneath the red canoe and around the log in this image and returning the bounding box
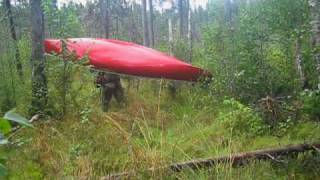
[1,81,320,179]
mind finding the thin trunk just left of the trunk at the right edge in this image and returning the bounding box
[295,35,306,88]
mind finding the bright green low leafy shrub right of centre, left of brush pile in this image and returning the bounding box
[218,99,266,136]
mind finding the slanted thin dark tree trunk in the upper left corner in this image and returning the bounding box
[4,0,23,79]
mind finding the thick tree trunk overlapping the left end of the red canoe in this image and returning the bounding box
[30,0,48,114]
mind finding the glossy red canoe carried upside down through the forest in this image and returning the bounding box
[44,38,210,81]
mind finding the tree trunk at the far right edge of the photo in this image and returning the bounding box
[309,0,320,89]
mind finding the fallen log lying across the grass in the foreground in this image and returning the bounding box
[101,143,320,179]
